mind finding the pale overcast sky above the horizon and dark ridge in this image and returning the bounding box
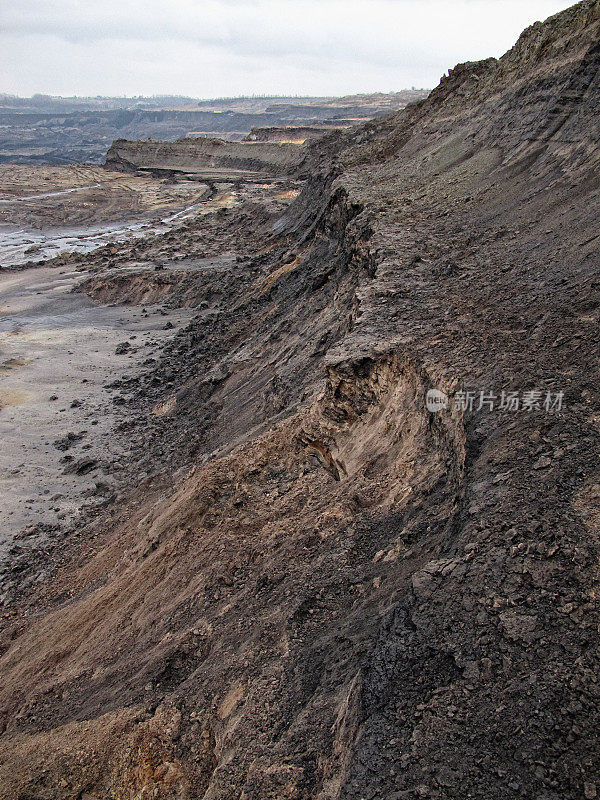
[0,0,572,98]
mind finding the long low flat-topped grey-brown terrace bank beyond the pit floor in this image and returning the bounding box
[106,138,305,181]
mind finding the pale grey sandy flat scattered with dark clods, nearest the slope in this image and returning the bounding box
[0,267,190,558]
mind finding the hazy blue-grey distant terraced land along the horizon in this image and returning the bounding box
[0,90,427,164]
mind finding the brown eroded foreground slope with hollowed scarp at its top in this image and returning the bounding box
[0,355,464,800]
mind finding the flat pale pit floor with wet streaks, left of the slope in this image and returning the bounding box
[0,166,295,564]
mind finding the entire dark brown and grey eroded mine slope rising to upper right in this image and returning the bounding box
[0,1,600,800]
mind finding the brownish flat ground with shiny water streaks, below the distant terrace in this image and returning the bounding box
[0,165,295,269]
